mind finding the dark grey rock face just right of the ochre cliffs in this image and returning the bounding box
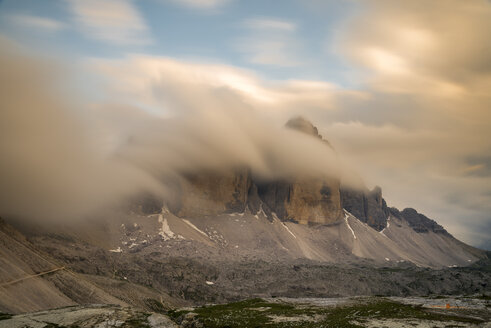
[340,186,389,231]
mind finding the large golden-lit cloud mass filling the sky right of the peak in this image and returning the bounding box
[317,0,491,249]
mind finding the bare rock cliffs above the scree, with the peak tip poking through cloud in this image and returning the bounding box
[133,117,458,238]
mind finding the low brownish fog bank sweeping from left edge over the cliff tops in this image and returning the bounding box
[0,40,346,220]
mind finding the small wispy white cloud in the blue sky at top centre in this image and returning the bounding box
[236,17,301,67]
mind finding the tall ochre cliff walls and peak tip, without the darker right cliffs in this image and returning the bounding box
[147,118,343,224]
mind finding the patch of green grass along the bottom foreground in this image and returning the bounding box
[168,298,482,328]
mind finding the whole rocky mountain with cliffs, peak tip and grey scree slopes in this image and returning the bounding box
[0,118,491,313]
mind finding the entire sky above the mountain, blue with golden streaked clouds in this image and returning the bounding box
[0,0,491,249]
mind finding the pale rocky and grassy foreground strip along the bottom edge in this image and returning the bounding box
[0,297,491,328]
